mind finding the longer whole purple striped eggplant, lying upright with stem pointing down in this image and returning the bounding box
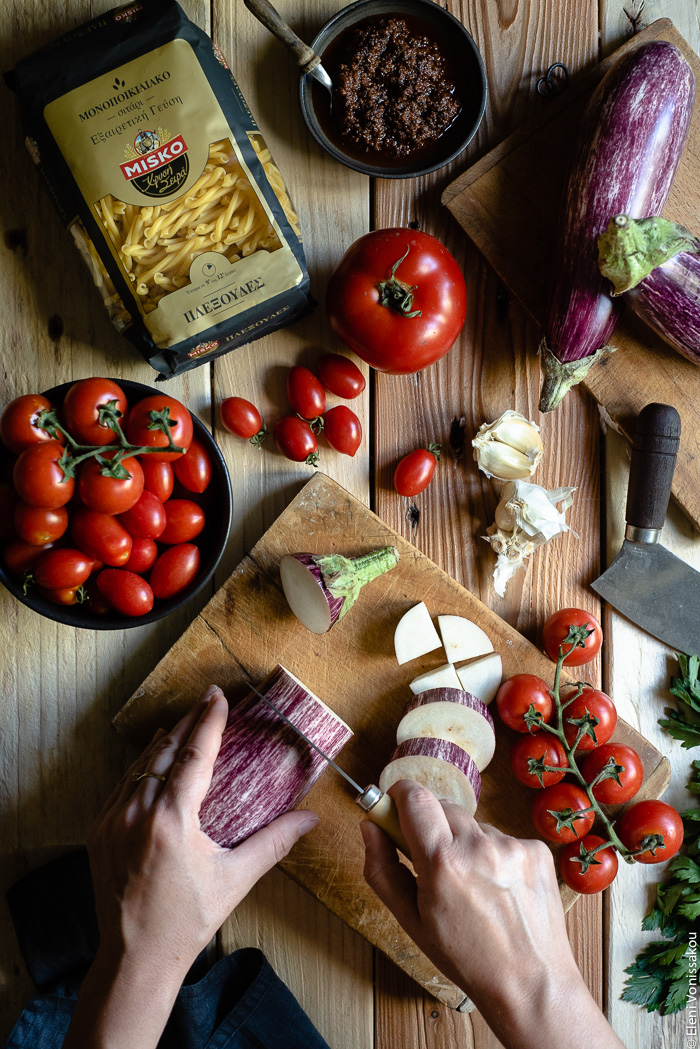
[539,40,695,411]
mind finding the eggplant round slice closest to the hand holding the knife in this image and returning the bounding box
[379,736,482,816]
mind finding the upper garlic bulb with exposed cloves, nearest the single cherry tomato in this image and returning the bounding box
[471,408,543,480]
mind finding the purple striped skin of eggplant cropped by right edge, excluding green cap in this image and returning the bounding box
[622,252,700,364]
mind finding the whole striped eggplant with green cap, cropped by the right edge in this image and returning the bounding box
[598,215,700,364]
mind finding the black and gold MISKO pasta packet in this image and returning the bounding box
[8,0,313,378]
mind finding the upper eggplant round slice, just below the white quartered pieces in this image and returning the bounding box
[397,688,495,772]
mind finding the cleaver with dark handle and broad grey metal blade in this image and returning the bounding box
[592,404,700,655]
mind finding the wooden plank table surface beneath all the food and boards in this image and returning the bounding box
[0,0,700,1049]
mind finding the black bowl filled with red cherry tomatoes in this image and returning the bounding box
[0,378,232,630]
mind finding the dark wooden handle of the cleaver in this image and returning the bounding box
[624,404,680,529]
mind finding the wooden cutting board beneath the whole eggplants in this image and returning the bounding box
[442,19,700,525]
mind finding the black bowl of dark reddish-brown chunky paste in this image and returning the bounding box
[299,0,486,178]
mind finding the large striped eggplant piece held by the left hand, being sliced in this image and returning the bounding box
[199,665,353,849]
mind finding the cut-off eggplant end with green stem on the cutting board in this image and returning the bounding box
[279,547,399,634]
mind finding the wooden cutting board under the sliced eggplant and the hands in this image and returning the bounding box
[114,473,670,1008]
